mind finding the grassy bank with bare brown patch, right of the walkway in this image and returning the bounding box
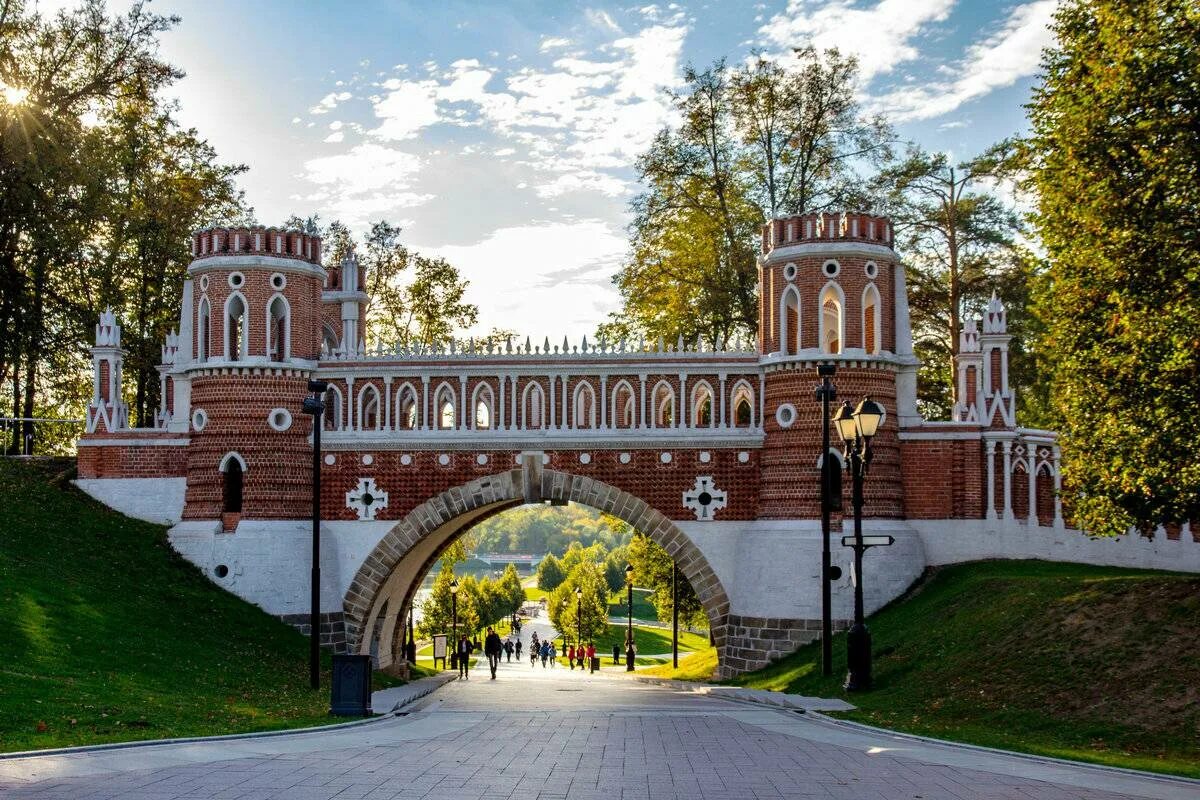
[720,561,1200,777]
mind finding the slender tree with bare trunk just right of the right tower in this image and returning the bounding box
[876,148,1022,419]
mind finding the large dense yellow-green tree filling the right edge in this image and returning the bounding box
[1028,0,1200,534]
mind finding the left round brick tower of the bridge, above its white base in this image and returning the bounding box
[181,228,326,530]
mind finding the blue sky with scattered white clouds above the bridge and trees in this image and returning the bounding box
[38,0,1055,341]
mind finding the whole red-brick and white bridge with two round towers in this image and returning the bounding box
[78,213,1200,675]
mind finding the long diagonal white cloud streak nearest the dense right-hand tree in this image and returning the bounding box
[876,0,1058,121]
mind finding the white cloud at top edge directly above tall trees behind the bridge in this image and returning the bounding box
[758,0,956,82]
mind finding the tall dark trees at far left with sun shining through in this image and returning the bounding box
[0,0,248,451]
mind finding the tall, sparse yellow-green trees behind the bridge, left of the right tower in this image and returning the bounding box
[600,48,892,347]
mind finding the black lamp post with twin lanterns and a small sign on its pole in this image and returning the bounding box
[834,397,883,692]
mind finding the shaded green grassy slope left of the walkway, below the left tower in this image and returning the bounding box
[0,459,397,751]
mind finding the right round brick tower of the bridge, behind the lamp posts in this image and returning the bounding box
[756,213,917,519]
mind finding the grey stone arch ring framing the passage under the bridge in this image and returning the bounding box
[343,465,731,674]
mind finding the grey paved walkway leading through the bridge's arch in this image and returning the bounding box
[0,661,1200,800]
